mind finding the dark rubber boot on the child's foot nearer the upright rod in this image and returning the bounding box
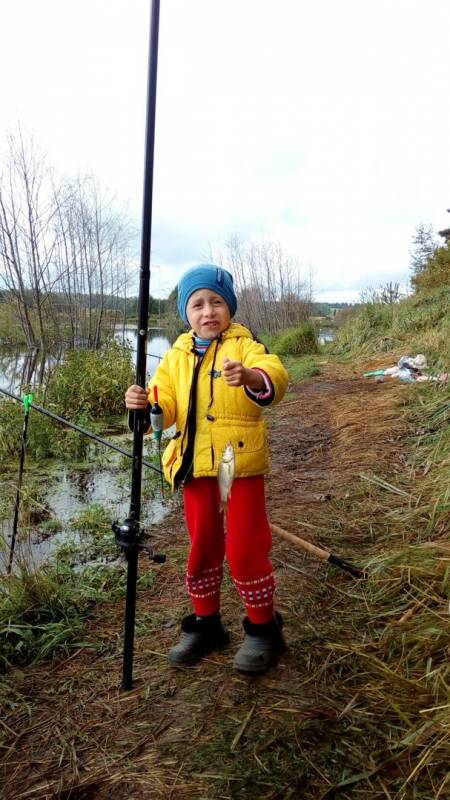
[169,614,230,667]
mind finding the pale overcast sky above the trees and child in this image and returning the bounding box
[0,0,450,300]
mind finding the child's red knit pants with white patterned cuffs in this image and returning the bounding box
[184,475,275,623]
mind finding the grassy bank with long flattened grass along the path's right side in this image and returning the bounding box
[316,289,450,800]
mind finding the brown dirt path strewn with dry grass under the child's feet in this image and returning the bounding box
[0,364,407,800]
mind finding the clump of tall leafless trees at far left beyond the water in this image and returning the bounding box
[0,129,135,350]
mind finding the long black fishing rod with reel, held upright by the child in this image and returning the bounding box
[113,0,165,689]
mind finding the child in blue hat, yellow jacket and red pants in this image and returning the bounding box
[125,264,288,674]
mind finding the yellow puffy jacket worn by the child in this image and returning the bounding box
[149,322,288,489]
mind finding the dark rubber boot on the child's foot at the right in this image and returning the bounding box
[234,611,286,675]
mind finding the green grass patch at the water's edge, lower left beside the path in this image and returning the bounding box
[0,504,157,672]
